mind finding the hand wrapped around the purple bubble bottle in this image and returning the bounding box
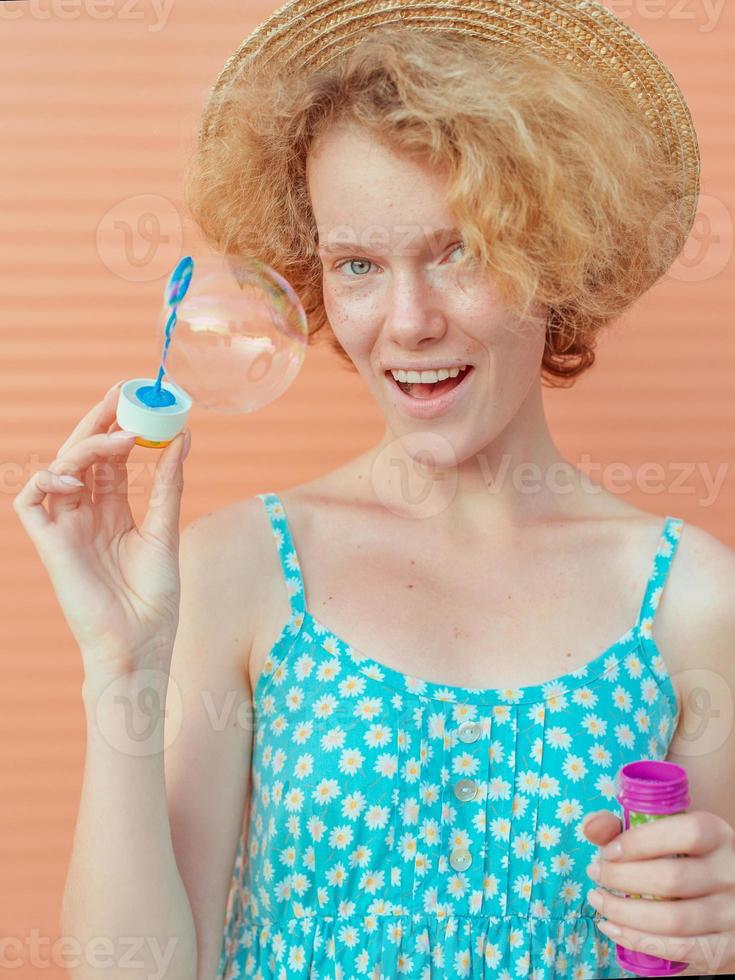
[583,810,735,975]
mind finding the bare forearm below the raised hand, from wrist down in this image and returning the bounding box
[61,676,197,980]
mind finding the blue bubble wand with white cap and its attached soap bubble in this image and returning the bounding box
[116,254,308,449]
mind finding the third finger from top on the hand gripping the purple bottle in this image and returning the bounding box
[587,888,733,936]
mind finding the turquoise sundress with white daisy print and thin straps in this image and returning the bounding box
[217,493,684,980]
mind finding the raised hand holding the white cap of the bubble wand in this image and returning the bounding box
[13,382,191,680]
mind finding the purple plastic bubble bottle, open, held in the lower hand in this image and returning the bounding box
[615,759,691,977]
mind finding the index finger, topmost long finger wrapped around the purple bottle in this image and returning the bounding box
[602,810,732,861]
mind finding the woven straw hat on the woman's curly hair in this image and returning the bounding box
[199,0,700,236]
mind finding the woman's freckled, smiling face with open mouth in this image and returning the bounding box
[307,127,545,462]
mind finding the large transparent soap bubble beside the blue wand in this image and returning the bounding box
[160,255,308,413]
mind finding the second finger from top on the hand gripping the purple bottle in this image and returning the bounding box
[586,857,726,898]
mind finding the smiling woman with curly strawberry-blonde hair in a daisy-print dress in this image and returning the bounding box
[17,4,735,978]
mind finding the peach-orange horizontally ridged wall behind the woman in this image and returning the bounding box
[0,0,735,980]
